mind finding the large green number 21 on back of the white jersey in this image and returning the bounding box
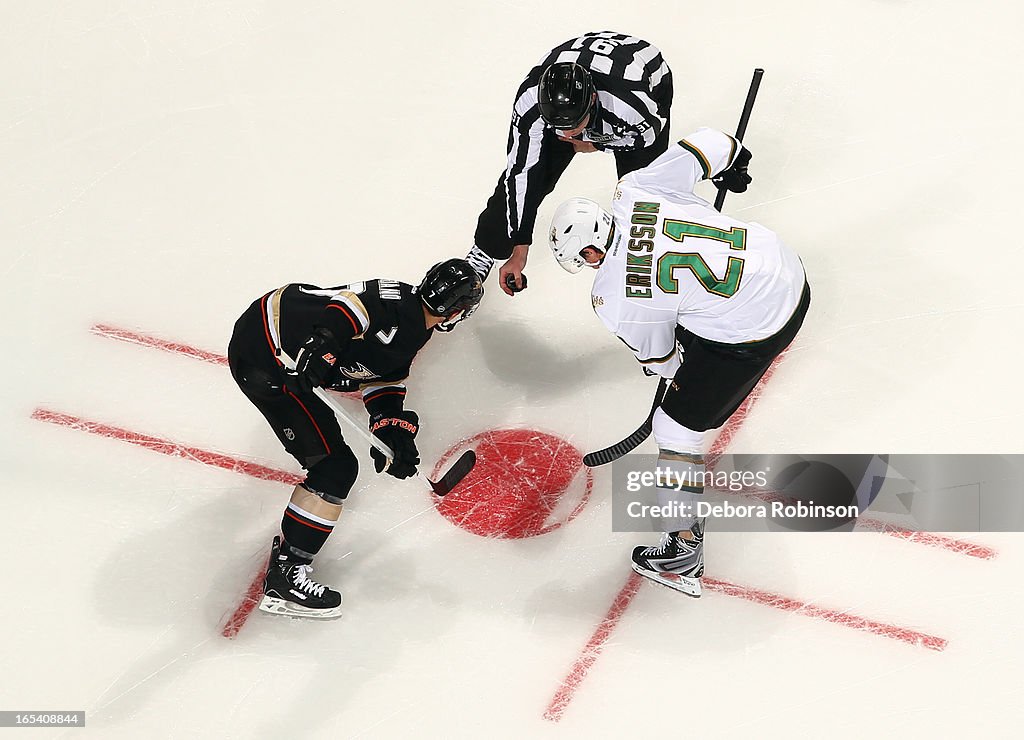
[657,219,746,298]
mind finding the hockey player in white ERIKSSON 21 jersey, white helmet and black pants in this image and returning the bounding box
[549,129,810,597]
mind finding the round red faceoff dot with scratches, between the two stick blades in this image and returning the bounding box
[434,429,594,539]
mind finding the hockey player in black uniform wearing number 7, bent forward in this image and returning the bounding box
[227,259,483,618]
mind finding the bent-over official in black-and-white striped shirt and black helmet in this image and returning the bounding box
[466,31,672,296]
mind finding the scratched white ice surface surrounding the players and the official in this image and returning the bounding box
[0,0,1024,738]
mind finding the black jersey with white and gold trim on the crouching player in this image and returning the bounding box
[265,278,431,413]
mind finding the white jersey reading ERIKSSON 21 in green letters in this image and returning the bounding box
[592,129,805,378]
